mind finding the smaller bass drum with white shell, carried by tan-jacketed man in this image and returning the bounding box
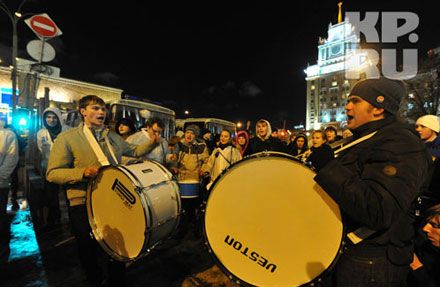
[87,161,181,262]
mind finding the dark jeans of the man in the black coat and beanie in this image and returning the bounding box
[334,249,409,287]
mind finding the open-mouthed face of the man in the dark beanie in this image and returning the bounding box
[345,96,381,130]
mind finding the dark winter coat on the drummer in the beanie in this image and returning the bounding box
[315,117,431,265]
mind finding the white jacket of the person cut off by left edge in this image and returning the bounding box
[0,128,18,188]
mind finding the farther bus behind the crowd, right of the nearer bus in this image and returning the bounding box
[176,118,237,137]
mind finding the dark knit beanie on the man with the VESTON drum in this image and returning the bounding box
[350,77,406,114]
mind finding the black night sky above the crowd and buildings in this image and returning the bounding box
[0,0,440,128]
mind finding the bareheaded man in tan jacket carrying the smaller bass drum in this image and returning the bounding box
[46,95,159,286]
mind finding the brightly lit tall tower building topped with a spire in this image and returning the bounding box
[304,2,366,130]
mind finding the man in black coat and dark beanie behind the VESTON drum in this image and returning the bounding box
[314,77,430,287]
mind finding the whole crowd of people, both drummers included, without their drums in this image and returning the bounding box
[0,78,440,287]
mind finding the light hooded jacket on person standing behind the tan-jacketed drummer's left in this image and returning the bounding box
[37,107,70,174]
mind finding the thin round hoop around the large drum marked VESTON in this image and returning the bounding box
[201,151,346,287]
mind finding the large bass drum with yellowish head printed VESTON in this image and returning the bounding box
[203,152,343,287]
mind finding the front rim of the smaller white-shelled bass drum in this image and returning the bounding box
[86,165,152,262]
